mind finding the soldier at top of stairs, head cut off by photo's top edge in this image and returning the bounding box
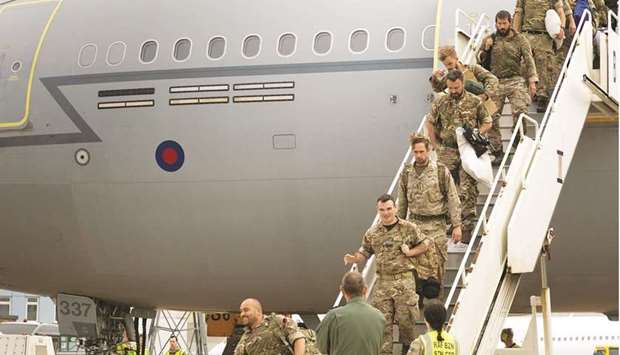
[513,0,566,112]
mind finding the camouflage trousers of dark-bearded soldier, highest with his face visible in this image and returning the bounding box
[487,76,532,153]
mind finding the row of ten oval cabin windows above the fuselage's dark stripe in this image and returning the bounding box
[78,27,406,68]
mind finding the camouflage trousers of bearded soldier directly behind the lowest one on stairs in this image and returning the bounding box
[412,219,448,282]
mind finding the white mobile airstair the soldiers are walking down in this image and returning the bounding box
[334,6,618,354]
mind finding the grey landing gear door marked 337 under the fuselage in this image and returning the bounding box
[56,293,97,339]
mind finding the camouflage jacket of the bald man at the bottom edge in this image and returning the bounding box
[235,314,304,355]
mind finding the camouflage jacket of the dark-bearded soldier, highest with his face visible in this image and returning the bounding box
[478,28,538,82]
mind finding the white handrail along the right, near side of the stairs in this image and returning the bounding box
[444,10,592,327]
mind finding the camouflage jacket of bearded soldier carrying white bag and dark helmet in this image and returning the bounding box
[427,90,493,148]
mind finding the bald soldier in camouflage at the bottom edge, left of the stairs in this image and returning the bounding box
[235,298,306,355]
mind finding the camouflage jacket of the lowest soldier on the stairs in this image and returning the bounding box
[359,218,427,275]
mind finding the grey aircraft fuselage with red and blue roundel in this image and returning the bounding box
[0,0,618,314]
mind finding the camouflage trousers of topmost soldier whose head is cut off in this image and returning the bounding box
[523,32,559,98]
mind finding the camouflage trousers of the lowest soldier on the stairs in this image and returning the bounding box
[371,273,420,355]
